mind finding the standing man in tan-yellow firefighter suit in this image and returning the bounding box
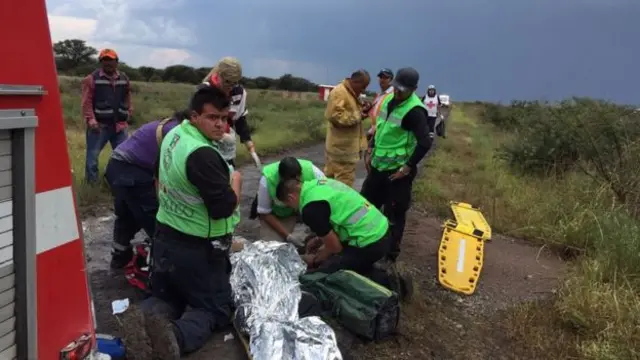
[324,70,371,186]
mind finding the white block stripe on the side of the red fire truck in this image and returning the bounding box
[36,186,80,254]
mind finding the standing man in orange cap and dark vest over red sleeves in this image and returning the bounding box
[82,49,132,184]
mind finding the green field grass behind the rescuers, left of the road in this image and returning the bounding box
[60,76,325,212]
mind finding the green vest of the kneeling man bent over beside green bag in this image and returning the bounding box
[300,179,389,247]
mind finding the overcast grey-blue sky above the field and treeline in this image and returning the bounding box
[47,0,640,104]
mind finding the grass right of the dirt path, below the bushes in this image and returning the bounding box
[415,105,640,360]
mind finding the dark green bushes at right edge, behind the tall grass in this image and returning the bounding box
[487,98,640,208]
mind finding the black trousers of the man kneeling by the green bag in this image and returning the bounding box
[308,232,392,288]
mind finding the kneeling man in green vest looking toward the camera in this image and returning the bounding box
[122,87,242,359]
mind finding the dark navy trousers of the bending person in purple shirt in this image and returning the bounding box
[105,158,158,250]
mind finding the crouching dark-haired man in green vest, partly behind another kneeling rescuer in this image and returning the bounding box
[251,156,325,247]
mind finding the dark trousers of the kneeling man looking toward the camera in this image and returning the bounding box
[142,224,233,354]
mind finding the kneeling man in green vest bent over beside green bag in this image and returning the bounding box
[277,179,413,299]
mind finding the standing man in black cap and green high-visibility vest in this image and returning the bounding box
[362,67,434,262]
